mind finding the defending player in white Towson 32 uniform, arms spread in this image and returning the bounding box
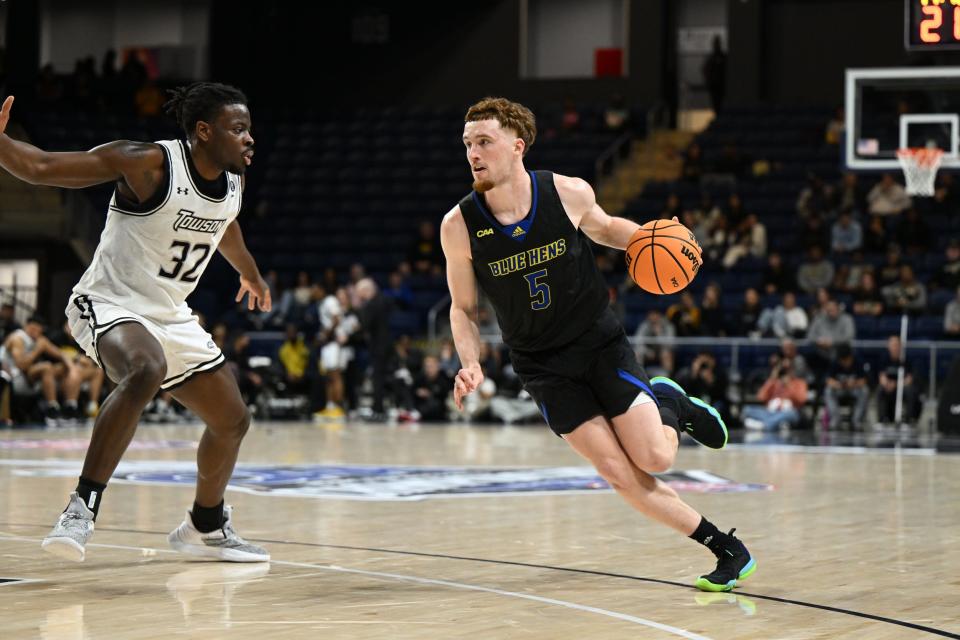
[0,83,271,562]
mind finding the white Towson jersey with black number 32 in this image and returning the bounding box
[73,140,243,322]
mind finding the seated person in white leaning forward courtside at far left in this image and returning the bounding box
[0,316,84,426]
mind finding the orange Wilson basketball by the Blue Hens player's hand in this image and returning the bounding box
[626,220,703,295]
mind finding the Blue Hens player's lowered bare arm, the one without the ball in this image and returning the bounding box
[440,207,483,410]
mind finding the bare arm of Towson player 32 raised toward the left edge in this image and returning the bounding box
[0,96,164,191]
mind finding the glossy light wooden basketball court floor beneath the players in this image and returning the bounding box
[0,423,960,640]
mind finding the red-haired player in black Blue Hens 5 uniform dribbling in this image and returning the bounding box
[440,98,757,591]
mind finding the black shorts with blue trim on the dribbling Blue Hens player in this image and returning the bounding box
[510,309,659,436]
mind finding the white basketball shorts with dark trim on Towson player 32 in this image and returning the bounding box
[66,295,225,390]
